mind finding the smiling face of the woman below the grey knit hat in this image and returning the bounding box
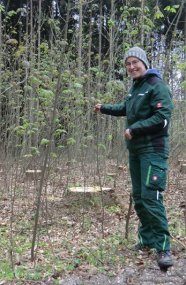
[125,56,147,79]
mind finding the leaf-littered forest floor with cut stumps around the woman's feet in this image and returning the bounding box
[0,159,186,285]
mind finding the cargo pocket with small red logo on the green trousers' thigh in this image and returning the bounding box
[146,161,167,191]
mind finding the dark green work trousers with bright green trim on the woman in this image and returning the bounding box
[129,153,170,252]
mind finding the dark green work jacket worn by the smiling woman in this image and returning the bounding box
[100,69,173,155]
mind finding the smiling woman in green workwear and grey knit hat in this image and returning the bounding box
[95,47,173,269]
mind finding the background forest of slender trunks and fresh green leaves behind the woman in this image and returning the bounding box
[0,0,186,159]
